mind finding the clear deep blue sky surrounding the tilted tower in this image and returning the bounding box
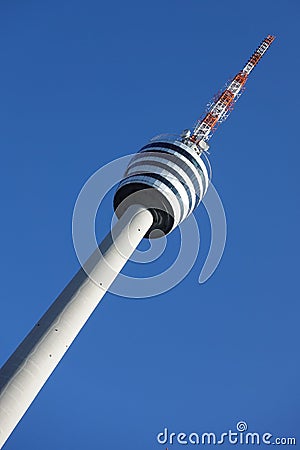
[0,0,300,450]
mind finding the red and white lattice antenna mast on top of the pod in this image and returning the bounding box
[189,35,275,144]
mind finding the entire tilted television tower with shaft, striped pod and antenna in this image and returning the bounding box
[0,35,274,448]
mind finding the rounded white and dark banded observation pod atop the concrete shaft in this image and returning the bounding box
[114,132,211,238]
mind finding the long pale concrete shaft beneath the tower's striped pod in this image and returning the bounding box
[0,206,153,448]
